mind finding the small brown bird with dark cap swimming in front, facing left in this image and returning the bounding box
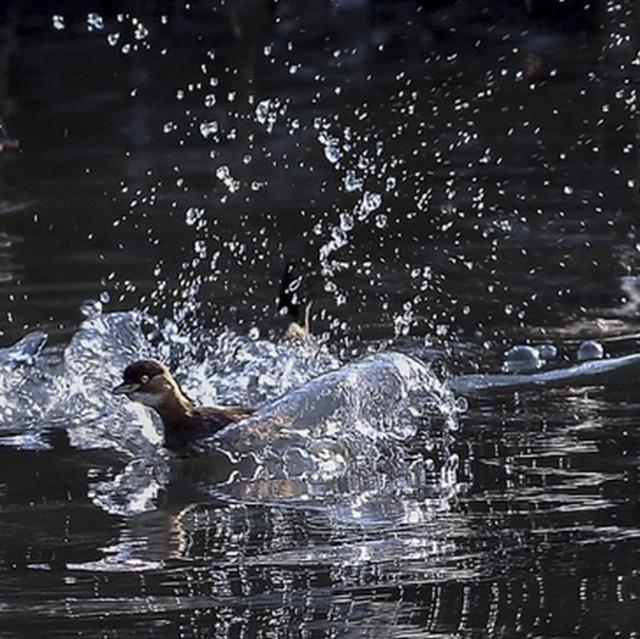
[111,359,255,452]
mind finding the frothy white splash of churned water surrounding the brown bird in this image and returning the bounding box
[0,307,458,521]
